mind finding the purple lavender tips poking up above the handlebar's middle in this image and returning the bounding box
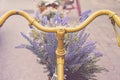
[35,11,69,26]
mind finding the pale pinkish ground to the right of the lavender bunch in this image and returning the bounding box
[81,0,120,80]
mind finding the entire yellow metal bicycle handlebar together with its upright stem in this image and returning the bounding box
[0,10,120,80]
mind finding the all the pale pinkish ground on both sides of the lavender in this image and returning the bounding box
[0,0,120,80]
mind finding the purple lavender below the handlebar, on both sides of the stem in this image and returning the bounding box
[18,30,103,80]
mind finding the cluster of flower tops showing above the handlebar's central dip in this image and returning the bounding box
[35,11,69,27]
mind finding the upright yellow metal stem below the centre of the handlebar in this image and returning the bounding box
[56,27,65,80]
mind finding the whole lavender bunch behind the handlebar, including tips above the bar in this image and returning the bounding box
[16,10,105,80]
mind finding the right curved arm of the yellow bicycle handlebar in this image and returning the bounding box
[66,10,120,32]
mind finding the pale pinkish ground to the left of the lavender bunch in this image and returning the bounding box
[0,0,47,80]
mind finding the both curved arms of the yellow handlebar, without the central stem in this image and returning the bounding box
[0,10,120,33]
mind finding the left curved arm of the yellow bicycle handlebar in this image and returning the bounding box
[0,10,57,32]
